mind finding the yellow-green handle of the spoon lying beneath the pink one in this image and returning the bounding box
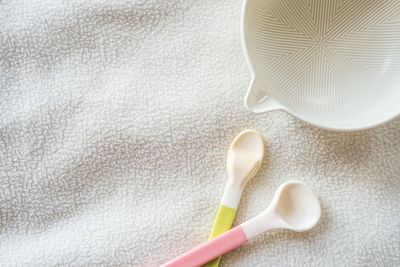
[203,204,236,267]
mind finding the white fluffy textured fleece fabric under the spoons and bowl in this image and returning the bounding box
[0,0,400,266]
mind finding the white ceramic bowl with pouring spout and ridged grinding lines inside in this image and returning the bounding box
[241,0,400,131]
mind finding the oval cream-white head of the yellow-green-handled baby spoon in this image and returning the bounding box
[227,130,264,187]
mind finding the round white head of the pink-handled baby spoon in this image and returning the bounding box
[272,181,321,232]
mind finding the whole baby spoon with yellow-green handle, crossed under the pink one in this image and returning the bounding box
[205,130,264,267]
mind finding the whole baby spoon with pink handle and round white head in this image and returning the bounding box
[163,181,321,267]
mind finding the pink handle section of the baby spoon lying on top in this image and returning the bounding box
[162,225,247,267]
